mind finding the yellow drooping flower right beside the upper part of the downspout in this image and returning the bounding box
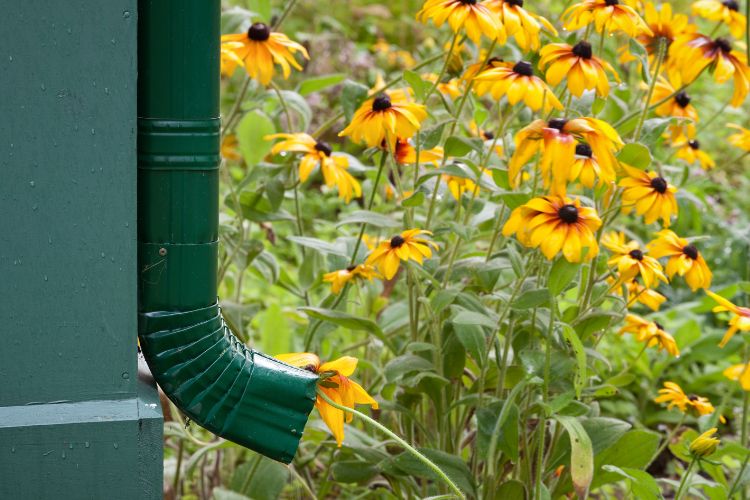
[221,23,310,85]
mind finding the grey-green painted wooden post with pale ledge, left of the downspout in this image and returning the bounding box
[0,0,162,499]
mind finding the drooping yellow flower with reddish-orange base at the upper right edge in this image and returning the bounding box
[669,33,750,107]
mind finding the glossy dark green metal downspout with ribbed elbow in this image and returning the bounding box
[138,0,317,463]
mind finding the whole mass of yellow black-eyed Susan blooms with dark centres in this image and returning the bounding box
[220,0,750,456]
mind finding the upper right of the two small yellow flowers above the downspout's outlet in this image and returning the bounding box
[366,229,437,280]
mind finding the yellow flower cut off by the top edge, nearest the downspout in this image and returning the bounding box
[417,0,507,43]
